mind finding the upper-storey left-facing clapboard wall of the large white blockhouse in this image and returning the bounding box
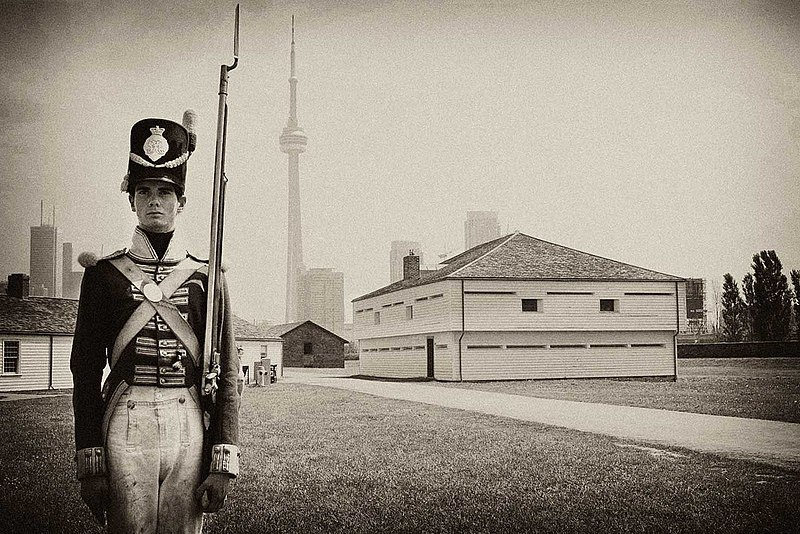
[353,280,461,339]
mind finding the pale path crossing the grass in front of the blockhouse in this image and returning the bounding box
[283,372,800,469]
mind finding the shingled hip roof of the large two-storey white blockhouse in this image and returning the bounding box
[353,232,683,302]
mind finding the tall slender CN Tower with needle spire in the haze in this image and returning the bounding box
[280,15,308,323]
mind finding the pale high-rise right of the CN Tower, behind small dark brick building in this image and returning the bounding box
[299,268,344,335]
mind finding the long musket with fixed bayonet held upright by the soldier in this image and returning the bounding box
[200,4,239,399]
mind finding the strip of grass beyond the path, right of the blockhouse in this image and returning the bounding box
[441,358,800,423]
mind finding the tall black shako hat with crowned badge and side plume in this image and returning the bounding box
[120,110,196,196]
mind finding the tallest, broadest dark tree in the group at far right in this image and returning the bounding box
[745,250,792,341]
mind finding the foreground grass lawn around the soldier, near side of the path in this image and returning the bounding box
[0,374,800,533]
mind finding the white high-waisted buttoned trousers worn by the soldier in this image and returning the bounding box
[106,386,203,534]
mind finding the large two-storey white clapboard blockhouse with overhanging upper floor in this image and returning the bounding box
[353,233,686,381]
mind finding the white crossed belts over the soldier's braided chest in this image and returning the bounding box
[109,255,202,369]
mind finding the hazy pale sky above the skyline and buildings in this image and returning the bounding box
[0,0,800,321]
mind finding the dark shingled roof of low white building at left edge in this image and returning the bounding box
[0,295,78,335]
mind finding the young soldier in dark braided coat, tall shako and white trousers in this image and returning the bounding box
[70,111,240,532]
